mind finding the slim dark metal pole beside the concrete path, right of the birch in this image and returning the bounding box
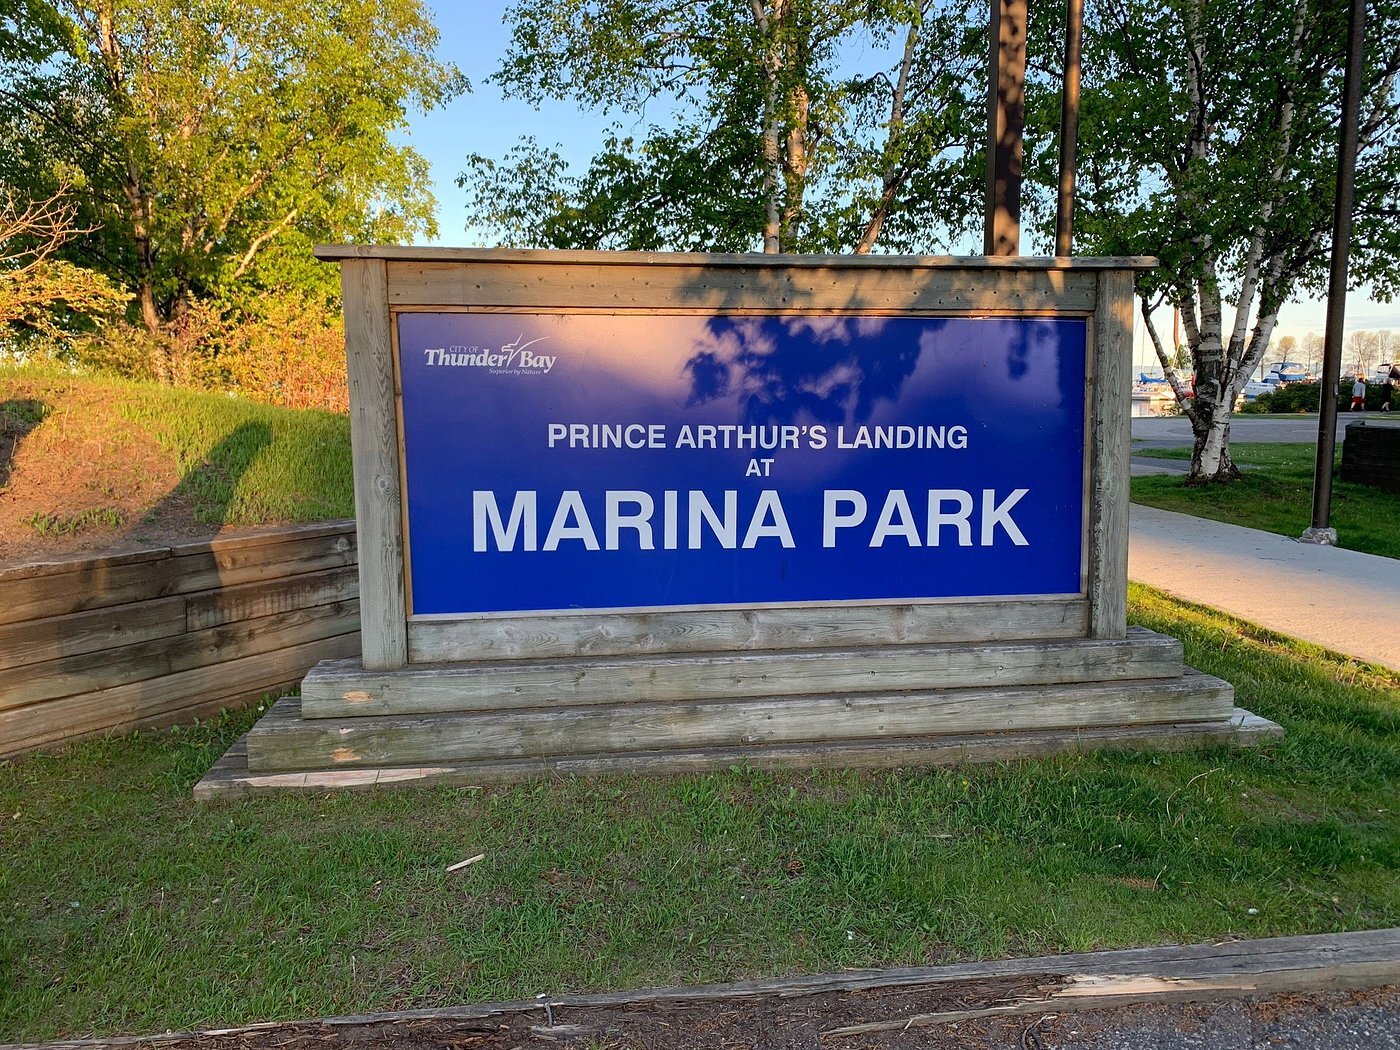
[1301,0,1366,543]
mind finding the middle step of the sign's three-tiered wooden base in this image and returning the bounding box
[248,672,1233,771]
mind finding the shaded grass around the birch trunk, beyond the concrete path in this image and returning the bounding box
[1133,442,1400,557]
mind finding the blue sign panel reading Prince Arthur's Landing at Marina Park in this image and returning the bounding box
[398,312,1086,615]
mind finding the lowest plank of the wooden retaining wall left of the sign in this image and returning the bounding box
[0,634,360,759]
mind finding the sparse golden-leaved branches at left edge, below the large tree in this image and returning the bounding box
[0,184,130,336]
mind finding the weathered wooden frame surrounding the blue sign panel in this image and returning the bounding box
[316,246,1155,669]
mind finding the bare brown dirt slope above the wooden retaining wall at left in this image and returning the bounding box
[0,379,218,566]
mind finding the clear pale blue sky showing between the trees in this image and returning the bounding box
[409,0,1400,360]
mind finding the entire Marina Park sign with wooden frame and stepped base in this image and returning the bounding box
[203,246,1277,794]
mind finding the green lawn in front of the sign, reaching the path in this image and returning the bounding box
[0,587,1400,1039]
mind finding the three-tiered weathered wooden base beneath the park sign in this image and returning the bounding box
[196,627,1281,798]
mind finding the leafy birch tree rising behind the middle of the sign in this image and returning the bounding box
[459,0,986,252]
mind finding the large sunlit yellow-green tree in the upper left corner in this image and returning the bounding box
[0,0,463,330]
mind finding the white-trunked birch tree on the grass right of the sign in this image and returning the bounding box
[1079,0,1400,483]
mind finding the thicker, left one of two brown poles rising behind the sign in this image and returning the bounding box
[983,0,1028,255]
